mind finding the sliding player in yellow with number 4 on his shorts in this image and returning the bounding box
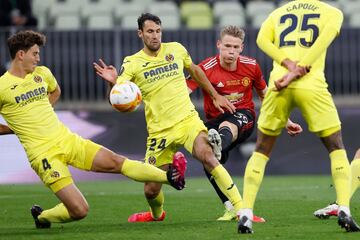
[0,31,185,228]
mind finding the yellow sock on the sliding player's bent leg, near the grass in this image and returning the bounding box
[38,203,74,223]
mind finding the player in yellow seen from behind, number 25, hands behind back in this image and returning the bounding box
[238,0,360,233]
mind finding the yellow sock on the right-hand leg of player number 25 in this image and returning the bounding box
[330,149,350,207]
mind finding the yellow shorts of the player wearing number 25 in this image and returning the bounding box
[258,88,341,137]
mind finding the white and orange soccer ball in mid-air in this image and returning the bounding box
[109,81,142,112]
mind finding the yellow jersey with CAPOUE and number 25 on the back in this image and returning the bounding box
[257,0,343,89]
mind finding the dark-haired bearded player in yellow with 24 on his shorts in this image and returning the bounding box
[94,13,242,225]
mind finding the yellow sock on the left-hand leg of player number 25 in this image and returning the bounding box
[243,152,269,209]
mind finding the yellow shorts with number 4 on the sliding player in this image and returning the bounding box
[30,134,101,192]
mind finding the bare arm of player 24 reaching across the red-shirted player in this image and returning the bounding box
[186,63,236,113]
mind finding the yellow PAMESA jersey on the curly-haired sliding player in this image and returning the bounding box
[0,66,69,161]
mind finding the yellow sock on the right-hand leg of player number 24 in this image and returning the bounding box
[210,164,242,211]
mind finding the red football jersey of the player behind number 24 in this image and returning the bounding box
[187,55,266,119]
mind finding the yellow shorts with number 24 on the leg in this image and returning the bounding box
[145,113,207,167]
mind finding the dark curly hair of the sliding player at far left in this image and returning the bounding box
[7,30,46,59]
